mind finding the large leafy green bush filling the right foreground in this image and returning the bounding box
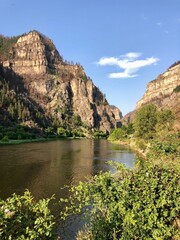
[60,162,180,240]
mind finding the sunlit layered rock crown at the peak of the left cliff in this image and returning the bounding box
[3,31,62,75]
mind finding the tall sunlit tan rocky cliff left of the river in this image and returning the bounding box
[0,31,121,131]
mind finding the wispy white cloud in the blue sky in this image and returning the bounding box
[97,52,159,78]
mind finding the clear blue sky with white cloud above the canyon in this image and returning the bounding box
[0,0,180,115]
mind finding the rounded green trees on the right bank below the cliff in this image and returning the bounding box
[109,104,174,141]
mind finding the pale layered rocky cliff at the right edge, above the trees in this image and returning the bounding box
[122,62,180,128]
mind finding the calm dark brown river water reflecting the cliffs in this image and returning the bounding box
[0,139,135,198]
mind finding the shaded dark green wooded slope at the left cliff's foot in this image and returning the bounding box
[0,78,107,143]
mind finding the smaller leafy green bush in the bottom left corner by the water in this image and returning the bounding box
[0,191,54,240]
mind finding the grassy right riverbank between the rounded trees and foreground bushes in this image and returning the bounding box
[110,132,180,171]
